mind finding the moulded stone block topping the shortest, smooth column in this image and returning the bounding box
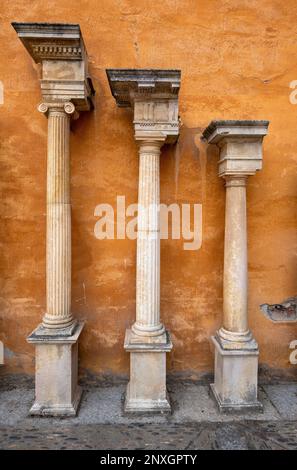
[202,120,269,178]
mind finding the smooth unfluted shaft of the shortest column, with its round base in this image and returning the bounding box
[220,176,249,340]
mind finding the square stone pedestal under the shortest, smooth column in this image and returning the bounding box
[210,337,263,413]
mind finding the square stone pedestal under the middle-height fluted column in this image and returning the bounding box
[124,330,172,413]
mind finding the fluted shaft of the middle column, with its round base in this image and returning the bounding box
[132,140,165,336]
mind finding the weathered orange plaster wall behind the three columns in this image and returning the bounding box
[0,0,297,374]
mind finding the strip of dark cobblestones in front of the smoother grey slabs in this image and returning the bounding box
[0,421,297,450]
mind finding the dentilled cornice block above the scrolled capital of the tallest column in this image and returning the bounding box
[12,23,95,111]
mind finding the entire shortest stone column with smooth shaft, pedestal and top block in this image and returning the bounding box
[203,121,269,411]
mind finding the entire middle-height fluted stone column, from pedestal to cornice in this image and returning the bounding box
[107,70,180,412]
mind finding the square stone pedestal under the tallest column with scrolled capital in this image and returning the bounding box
[27,322,84,416]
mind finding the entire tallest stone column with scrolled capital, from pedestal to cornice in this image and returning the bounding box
[13,23,94,416]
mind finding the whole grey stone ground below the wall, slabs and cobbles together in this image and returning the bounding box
[0,377,297,450]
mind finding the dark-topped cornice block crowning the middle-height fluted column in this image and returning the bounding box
[106,69,180,143]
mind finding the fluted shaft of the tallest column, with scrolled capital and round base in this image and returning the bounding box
[39,103,75,329]
